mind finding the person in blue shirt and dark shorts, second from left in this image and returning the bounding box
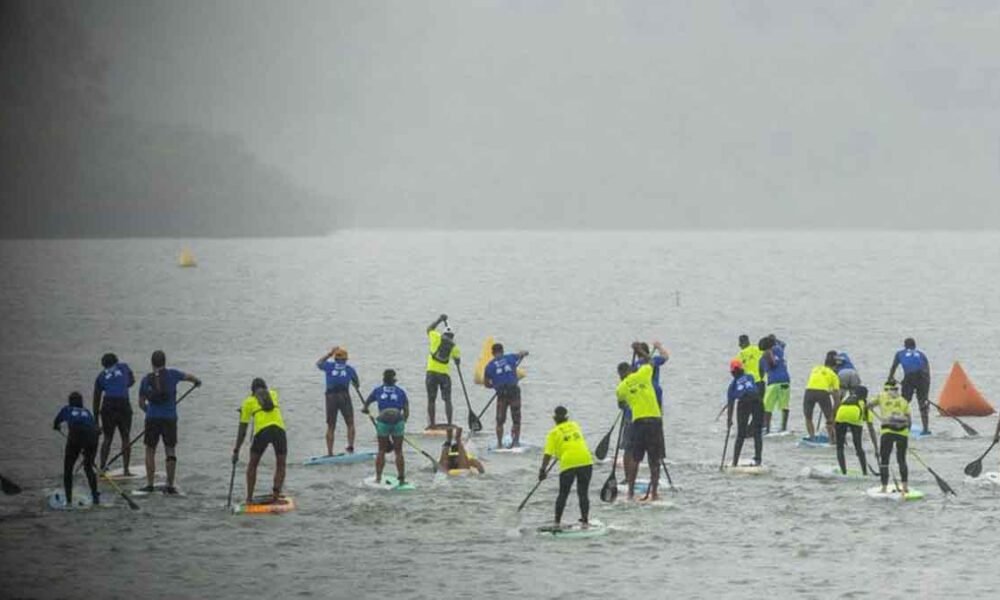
[93,352,135,477]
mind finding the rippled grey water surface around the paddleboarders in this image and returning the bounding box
[0,231,1000,598]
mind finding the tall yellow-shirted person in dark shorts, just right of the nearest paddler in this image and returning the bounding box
[616,344,663,500]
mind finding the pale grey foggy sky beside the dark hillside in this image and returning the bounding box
[5,0,1000,233]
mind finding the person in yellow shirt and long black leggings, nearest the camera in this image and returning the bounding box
[538,406,594,527]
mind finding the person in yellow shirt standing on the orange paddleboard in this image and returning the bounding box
[233,377,288,504]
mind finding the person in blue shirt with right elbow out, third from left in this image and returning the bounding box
[139,350,201,494]
